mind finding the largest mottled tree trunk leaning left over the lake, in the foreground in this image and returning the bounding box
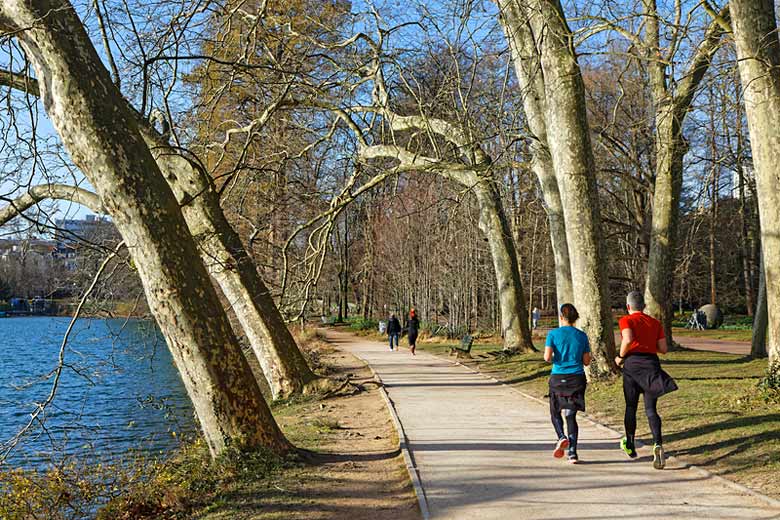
[0,0,290,455]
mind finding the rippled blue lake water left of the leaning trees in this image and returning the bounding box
[0,317,195,467]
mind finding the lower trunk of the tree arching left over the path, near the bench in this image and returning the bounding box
[473,174,536,352]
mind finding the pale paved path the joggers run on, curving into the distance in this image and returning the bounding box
[328,331,780,520]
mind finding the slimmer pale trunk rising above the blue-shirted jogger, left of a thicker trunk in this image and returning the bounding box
[498,0,574,309]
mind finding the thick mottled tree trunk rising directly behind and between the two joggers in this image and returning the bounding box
[529,0,616,379]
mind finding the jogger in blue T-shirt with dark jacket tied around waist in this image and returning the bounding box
[544,303,590,464]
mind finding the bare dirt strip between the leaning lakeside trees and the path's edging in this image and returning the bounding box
[196,336,420,520]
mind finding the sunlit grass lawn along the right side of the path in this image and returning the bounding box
[418,340,780,498]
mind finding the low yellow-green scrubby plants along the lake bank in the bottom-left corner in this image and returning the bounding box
[0,440,292,520]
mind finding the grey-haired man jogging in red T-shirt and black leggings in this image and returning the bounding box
[615,291,677,469]
